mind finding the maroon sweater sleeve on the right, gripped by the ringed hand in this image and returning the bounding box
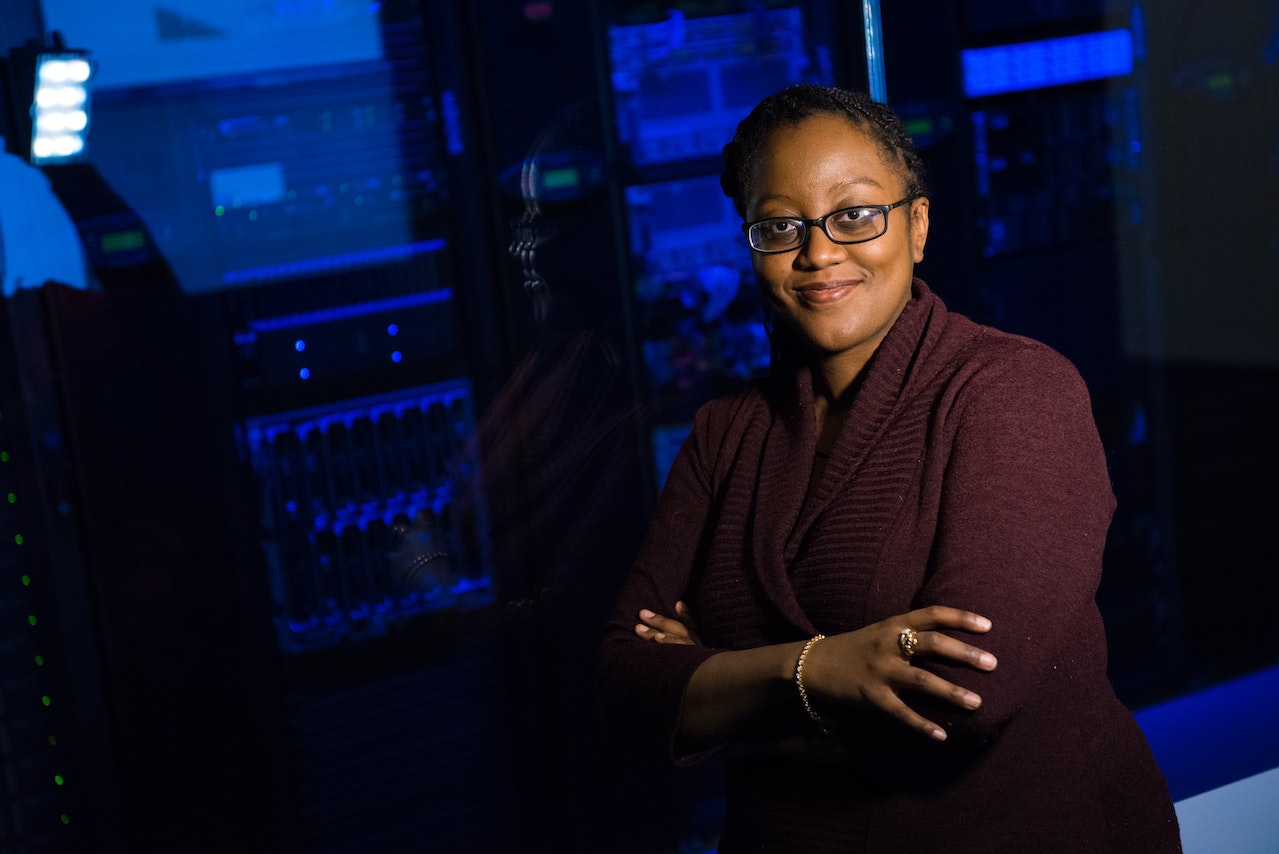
[916,343,1114,743]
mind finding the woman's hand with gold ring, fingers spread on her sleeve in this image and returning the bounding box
[803,605,998,741]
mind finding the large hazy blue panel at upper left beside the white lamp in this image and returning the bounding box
[79,15,450,293]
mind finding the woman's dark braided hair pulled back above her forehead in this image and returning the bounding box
[720,84,927,219]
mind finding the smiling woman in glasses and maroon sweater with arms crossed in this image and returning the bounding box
[601,87,1179,854]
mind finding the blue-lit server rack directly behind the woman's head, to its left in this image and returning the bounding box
[597,1,867,487]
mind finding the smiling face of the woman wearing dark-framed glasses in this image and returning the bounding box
[747,114,929,372]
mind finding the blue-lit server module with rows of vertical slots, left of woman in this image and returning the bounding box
[246,380,492,652]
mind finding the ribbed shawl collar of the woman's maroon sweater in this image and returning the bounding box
[746,279,946,634]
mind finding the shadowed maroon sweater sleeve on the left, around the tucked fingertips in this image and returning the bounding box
[599,398,723,763]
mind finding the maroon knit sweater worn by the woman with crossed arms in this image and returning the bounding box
[601,281,1181,854]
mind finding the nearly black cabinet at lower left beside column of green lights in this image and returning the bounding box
[6,284,288,850]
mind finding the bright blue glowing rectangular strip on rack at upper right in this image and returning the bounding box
[962,29,1133,97]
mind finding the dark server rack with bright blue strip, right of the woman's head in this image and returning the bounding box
[885,0,1187,704]
